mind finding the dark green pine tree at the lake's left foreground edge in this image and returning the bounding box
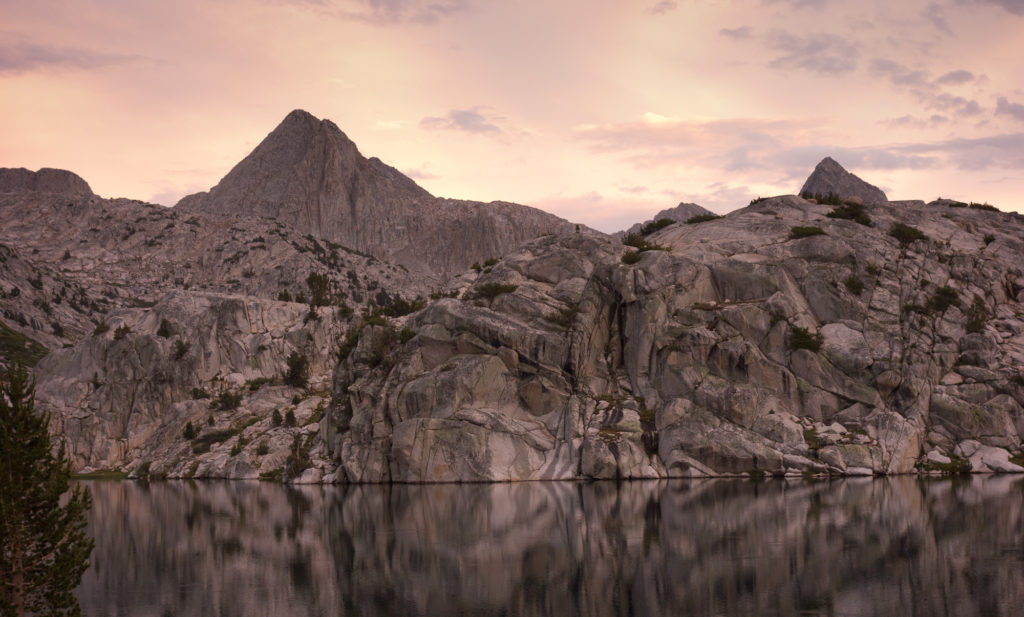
[0,366,93,617]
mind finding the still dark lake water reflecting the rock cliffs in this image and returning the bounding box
[78,476,1024,617]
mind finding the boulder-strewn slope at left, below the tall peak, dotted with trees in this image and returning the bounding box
[0,181,432,365]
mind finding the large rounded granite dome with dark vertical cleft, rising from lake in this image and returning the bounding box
[324,196,1024,482]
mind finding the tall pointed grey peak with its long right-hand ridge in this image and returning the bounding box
[175,109,571,278]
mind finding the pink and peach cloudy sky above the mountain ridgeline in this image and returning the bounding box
[0,0,1024,231]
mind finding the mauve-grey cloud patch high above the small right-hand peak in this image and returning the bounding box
[767,30,860,75]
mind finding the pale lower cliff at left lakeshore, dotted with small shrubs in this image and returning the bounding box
[36,292,344,478]
